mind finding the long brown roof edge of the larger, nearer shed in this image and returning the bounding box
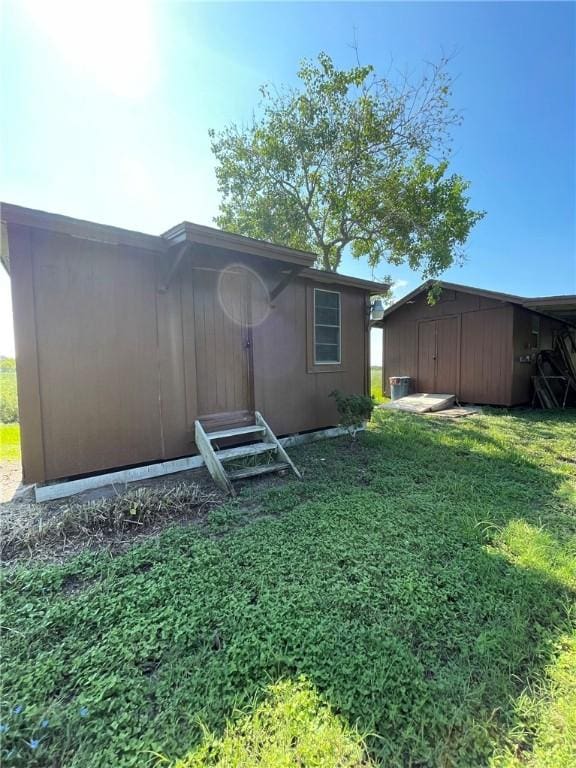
[0,203,389,294]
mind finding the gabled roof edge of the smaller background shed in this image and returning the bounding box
[375,280,576,327]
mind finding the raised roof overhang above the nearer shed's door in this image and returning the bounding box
[162,221,316,267]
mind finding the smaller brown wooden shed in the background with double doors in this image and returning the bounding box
[375,281,576,406]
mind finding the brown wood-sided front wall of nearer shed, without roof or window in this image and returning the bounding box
[9,225,368,482]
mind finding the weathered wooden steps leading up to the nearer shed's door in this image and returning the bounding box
[194,411,302,496]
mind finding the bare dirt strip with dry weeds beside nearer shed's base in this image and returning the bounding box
[0,452,306,568]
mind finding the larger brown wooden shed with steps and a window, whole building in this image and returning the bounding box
[1,204,387,483]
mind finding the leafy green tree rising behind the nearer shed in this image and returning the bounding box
[210,53,484,278]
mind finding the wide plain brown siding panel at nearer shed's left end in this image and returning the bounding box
[30,230,162,478]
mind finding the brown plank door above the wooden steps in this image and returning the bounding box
[192,269,253,424]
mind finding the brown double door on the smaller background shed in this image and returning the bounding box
[418,315,459,394]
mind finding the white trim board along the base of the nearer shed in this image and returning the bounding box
[34,427,363,502]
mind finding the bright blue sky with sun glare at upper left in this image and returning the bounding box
[0,0,576,361]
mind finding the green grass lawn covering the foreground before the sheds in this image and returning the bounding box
[1,411,576,768]
